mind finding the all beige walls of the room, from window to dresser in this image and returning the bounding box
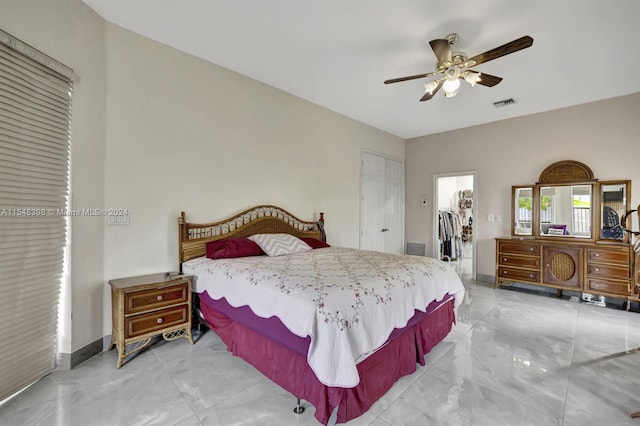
[0,0,640,352]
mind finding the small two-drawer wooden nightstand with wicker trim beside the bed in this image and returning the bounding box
[109,272,193,368]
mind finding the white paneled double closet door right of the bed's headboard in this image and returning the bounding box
[360,152,404,253]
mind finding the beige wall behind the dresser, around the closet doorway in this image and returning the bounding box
[406,94,640,276]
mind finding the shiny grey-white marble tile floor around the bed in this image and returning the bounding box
[0,281,640,426]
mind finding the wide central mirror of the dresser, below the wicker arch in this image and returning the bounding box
[537,184,593,238]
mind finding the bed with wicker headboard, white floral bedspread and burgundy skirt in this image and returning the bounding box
[178,205,464,424]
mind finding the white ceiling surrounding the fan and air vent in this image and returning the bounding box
[84,0,640,138]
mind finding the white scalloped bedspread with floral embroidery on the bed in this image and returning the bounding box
[183,247,464,388]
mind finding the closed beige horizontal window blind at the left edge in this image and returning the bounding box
[0,31,73,400]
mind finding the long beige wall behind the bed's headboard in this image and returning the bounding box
[104,24,404,334]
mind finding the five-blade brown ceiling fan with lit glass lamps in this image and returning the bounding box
[384,33,533,102]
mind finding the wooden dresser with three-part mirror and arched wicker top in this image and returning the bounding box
[495,160,640,307]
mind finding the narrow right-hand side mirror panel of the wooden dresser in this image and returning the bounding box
[598,180,631,241]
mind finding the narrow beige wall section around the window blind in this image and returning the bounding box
[0,0,105,352]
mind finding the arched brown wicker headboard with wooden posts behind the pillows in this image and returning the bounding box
[178,205,327,270]
